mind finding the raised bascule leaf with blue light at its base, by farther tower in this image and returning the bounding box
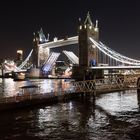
[42,52,60,73]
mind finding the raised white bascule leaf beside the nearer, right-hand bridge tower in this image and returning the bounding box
[63,50,79,64]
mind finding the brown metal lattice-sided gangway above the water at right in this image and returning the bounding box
[72,75,139,92]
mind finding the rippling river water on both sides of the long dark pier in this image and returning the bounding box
[0,79,140,140]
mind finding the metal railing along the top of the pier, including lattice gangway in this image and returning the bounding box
[0,75,139,104]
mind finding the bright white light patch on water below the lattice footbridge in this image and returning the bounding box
[97,90,138,115]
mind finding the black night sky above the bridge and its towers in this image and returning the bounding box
[0,0,140,59]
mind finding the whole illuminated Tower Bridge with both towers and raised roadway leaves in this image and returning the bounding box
[3,13,140,80]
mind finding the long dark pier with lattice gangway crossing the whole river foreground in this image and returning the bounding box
[0,75,139,111]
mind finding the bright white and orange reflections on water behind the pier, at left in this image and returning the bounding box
[0,78,70,97]
